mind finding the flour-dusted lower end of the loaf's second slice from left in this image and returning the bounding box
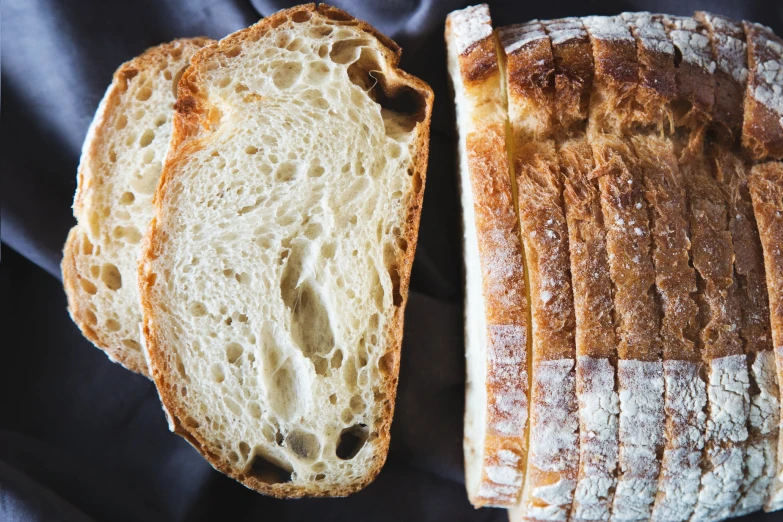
[509,359,579,521]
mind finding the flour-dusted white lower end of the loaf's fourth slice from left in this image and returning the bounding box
[612,360,664,520]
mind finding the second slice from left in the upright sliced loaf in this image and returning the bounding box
[498,21,579,520]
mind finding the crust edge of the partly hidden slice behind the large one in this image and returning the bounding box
[61,37,211,377]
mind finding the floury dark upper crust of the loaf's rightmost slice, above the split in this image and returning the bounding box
[742,22,783,160]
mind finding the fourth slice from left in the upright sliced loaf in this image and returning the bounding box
[584,17,664,519]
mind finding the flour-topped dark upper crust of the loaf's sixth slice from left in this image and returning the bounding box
[661,15,715,127]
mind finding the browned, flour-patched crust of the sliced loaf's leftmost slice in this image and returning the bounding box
[445,5,528,507]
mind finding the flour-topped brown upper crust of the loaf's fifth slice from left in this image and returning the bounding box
[620,12,677,130]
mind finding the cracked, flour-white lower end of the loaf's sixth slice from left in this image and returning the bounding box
[692,354,750,521]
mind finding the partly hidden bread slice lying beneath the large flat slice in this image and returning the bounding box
[62,38,210,375]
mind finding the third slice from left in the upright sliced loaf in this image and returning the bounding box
[543,18,619,520]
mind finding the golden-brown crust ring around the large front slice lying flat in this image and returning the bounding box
[138,4,433,498]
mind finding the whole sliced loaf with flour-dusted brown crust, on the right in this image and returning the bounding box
[446,5,783,521]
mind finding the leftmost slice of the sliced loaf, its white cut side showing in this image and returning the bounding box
[446,5,528,507]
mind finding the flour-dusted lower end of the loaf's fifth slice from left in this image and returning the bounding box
[651,361,707,522]
